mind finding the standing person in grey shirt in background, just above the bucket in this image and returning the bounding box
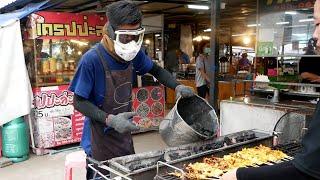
[195,44,210,98]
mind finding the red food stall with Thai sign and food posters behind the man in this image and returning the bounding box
[23,12,164,154]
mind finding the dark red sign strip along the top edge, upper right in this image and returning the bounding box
[259,0,315,13]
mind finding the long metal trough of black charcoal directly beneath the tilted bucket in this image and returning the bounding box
[106,130,273,180]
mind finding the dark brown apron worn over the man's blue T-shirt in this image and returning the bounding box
[90,46,134,166]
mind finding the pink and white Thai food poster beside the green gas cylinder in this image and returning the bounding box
[32,85,84,148]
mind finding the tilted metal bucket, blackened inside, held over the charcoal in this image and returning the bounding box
[159,95,218,146]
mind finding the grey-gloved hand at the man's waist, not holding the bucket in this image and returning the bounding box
[106,112,139,133]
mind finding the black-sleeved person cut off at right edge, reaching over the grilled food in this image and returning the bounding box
[222,0,320,180]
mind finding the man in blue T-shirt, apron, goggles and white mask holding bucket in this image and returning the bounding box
[70,1,194,179]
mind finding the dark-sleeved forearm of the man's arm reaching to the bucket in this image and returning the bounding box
[149,63,180,89]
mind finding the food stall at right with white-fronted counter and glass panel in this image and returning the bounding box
[220,0,320,140]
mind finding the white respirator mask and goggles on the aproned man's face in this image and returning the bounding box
[114,28,145,61]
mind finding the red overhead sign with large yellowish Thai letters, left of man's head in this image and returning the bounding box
[27,11,106,40]
